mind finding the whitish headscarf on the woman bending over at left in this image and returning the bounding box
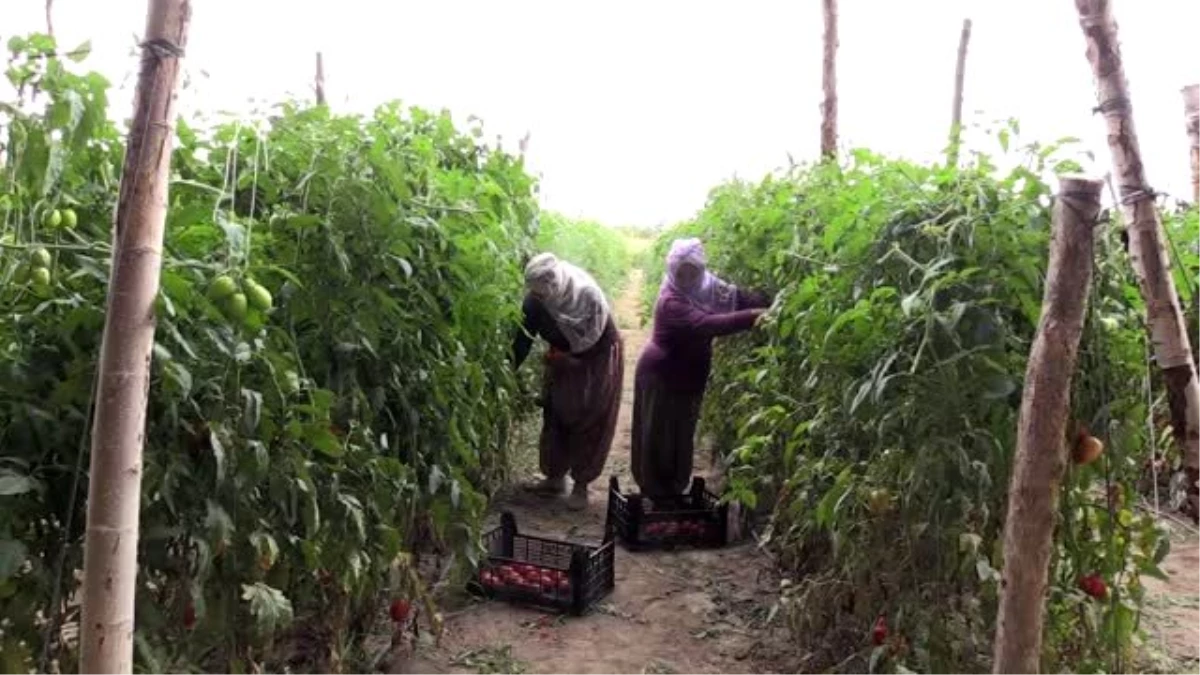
[526,253,608,354]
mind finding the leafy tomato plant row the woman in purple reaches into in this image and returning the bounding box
[652,130,1168,673]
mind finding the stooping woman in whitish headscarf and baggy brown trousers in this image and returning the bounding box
[514,253,625,509]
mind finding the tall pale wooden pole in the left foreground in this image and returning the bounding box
[79,0,191,675]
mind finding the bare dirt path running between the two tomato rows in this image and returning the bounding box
[403,270,794,675]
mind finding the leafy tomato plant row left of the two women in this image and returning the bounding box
[0,36,549,671]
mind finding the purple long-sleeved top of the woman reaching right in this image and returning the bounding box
[637,287,770,394]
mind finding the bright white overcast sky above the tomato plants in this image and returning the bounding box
[7,0,1200,225]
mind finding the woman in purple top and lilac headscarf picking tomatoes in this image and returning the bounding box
[631,239,769,498]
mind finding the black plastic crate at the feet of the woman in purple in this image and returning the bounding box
[605,476,730,550]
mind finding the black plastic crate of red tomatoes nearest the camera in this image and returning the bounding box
[469,512,616,616]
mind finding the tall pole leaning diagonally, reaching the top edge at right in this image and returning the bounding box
[1075,0,1200,518]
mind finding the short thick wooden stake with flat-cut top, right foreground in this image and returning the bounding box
[992,177,1104,675]
